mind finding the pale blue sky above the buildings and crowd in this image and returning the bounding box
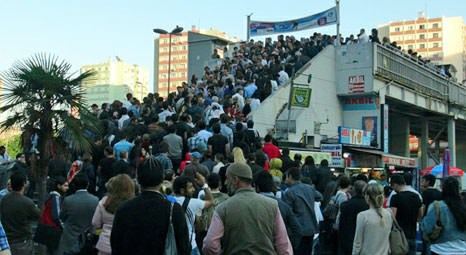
[0,0,466,88]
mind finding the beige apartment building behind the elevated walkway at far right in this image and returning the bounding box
[378,13,466,82]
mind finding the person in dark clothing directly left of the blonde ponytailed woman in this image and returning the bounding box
[337,181,369,255]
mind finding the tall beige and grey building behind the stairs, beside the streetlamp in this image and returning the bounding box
[154,27,230,97]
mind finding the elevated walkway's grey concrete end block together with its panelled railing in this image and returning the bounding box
[337,43,466,109]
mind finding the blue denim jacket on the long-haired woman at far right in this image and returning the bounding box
[421,201,466,243]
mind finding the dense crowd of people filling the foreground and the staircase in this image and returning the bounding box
[0,31,466,255]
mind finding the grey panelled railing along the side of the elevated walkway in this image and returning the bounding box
[373,44,450,102]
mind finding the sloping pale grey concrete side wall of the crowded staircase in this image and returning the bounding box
[252,46,342,147]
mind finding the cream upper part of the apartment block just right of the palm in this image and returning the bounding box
[81,57,149,101]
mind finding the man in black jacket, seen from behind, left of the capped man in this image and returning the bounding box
[110,158,191,255]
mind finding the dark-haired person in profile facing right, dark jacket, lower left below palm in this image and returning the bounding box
[34,176,68,255]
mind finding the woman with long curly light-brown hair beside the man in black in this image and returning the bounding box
[92,174,135,255]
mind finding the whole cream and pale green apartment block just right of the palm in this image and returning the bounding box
[81,57,149,104]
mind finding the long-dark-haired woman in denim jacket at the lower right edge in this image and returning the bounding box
[421,177,466,254]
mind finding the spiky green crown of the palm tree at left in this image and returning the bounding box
[0,53,99,151]
